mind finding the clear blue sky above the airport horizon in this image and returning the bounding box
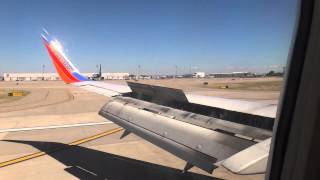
[0,0,297,74]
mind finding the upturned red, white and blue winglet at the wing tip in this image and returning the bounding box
[41,29,88,84]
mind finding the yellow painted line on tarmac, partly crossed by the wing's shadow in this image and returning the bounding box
[0,127,123,168]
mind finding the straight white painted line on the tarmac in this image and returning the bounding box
[0,121,113,133]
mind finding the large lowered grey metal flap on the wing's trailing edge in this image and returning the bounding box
[99,97,255,173]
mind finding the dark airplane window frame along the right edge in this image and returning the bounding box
[266,0,320,179]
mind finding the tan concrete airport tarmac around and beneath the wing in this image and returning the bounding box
[0,81,279,180]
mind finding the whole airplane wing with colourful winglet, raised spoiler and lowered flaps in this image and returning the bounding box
[42,31,276,174]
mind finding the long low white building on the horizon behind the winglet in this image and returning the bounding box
[3,73,129,81]
